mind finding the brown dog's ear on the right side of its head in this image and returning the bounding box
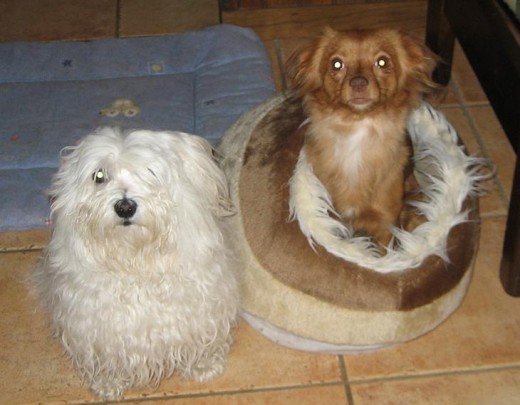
[401,33,441,93]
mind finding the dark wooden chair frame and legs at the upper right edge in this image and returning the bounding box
[426,0,520,297]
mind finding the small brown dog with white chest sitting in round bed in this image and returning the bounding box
[287,28,437,246]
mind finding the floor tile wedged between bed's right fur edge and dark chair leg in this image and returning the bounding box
[469,106,516,198]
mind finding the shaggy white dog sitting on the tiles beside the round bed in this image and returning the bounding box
[30,128,238,399]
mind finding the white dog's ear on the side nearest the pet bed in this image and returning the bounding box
[184,135,234,216]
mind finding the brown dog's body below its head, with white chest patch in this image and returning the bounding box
[305,110,410,233]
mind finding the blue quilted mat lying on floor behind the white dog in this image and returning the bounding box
[0,25,275,231]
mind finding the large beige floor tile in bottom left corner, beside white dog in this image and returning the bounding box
[0,252,91,404]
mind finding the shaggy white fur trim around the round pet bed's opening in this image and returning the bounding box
[289,103,490,273]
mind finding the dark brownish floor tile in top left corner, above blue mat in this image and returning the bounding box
[0,0,117,41]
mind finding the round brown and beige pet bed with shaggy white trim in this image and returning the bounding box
[219,96,480,353]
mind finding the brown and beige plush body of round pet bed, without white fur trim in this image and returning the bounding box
[219,96,480,349]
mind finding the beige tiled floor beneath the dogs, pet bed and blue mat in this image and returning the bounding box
[0,0,520,405]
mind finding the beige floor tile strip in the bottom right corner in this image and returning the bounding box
[352,369,520,405]
